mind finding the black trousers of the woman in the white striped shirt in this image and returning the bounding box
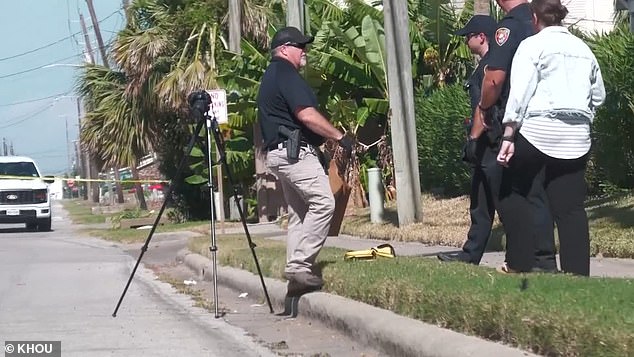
[500,135,590,275]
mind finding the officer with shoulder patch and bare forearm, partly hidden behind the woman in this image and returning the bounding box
[467,0,557,272]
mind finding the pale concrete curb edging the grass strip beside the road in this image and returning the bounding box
[176,249,537,357]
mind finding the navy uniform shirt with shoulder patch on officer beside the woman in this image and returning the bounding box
[489,3,535,108]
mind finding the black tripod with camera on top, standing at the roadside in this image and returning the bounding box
[112,91,273,318]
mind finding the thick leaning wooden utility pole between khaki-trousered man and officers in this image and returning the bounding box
[383,0,423,227]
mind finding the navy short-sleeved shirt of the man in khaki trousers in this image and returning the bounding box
[257,57,323,148]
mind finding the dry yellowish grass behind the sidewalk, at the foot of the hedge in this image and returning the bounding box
[341,192,634,258]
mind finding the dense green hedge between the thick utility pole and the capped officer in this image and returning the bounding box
[415,84,471,195]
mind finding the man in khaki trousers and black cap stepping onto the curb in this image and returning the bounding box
[257,27,353,296]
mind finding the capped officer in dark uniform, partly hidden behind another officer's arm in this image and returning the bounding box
[438,15,502,265]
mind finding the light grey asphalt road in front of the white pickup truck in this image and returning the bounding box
[0,202,273,357]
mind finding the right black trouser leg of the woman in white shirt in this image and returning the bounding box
[546,155,590,276]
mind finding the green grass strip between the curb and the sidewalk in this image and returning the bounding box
[189,236,634,356]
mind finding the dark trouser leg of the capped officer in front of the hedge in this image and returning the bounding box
[462,139,502,264]
